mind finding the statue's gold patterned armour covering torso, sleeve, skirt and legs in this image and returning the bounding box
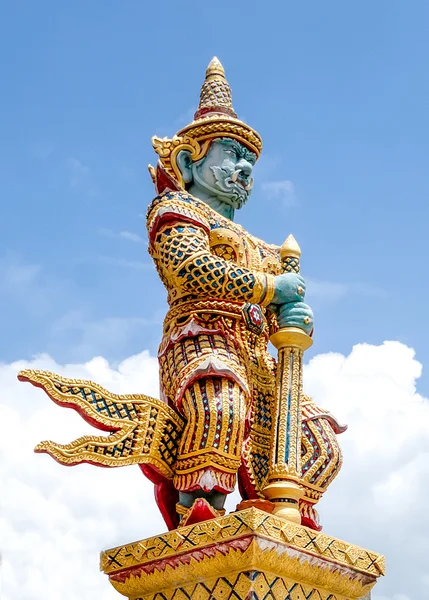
[147,191,341,523]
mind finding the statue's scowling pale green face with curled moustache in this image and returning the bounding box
[192,138,256,210]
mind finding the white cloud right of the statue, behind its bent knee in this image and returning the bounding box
[305,342,429,600]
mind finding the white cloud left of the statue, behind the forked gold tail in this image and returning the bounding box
[0,352,165,600]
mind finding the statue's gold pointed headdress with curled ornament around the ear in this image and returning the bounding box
[149,57,262,193]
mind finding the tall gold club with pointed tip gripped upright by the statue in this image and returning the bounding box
[263,235,313,523]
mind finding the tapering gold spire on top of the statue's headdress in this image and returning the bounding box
[194,56,237,119]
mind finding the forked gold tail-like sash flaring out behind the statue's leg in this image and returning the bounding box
[18,370,184,481]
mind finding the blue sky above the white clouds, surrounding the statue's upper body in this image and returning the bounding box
[0,0,429,394]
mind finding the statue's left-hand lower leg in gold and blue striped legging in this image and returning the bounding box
[174,376,247,510]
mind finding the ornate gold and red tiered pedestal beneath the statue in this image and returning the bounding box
[101,508,384,600]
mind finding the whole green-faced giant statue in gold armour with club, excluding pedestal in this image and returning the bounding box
[19,58,345,529]
